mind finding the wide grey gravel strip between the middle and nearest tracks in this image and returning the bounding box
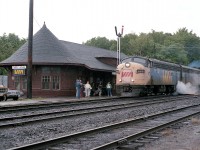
[0,99,200,150]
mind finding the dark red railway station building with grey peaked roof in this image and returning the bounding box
[0,24,126,97]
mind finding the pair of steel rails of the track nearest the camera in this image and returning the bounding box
[10,104,200,150]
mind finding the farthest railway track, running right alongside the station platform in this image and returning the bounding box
[0,95,186,113]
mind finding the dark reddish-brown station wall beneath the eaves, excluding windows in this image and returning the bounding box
[8,65,115,97]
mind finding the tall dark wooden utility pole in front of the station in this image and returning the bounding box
[27,0,33,99]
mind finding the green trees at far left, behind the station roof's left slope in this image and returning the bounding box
[0,33,27,75]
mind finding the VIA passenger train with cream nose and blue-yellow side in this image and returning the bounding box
[116,56,200,96]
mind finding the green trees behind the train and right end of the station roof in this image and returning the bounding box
[85,28,200,65]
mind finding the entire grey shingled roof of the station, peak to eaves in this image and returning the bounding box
[0,24,126,71]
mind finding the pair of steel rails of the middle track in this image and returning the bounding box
[0,97,183,129]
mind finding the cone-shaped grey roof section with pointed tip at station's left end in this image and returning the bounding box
[1,24,70,64]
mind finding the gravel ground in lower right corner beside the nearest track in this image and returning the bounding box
[138,118,200,150]
